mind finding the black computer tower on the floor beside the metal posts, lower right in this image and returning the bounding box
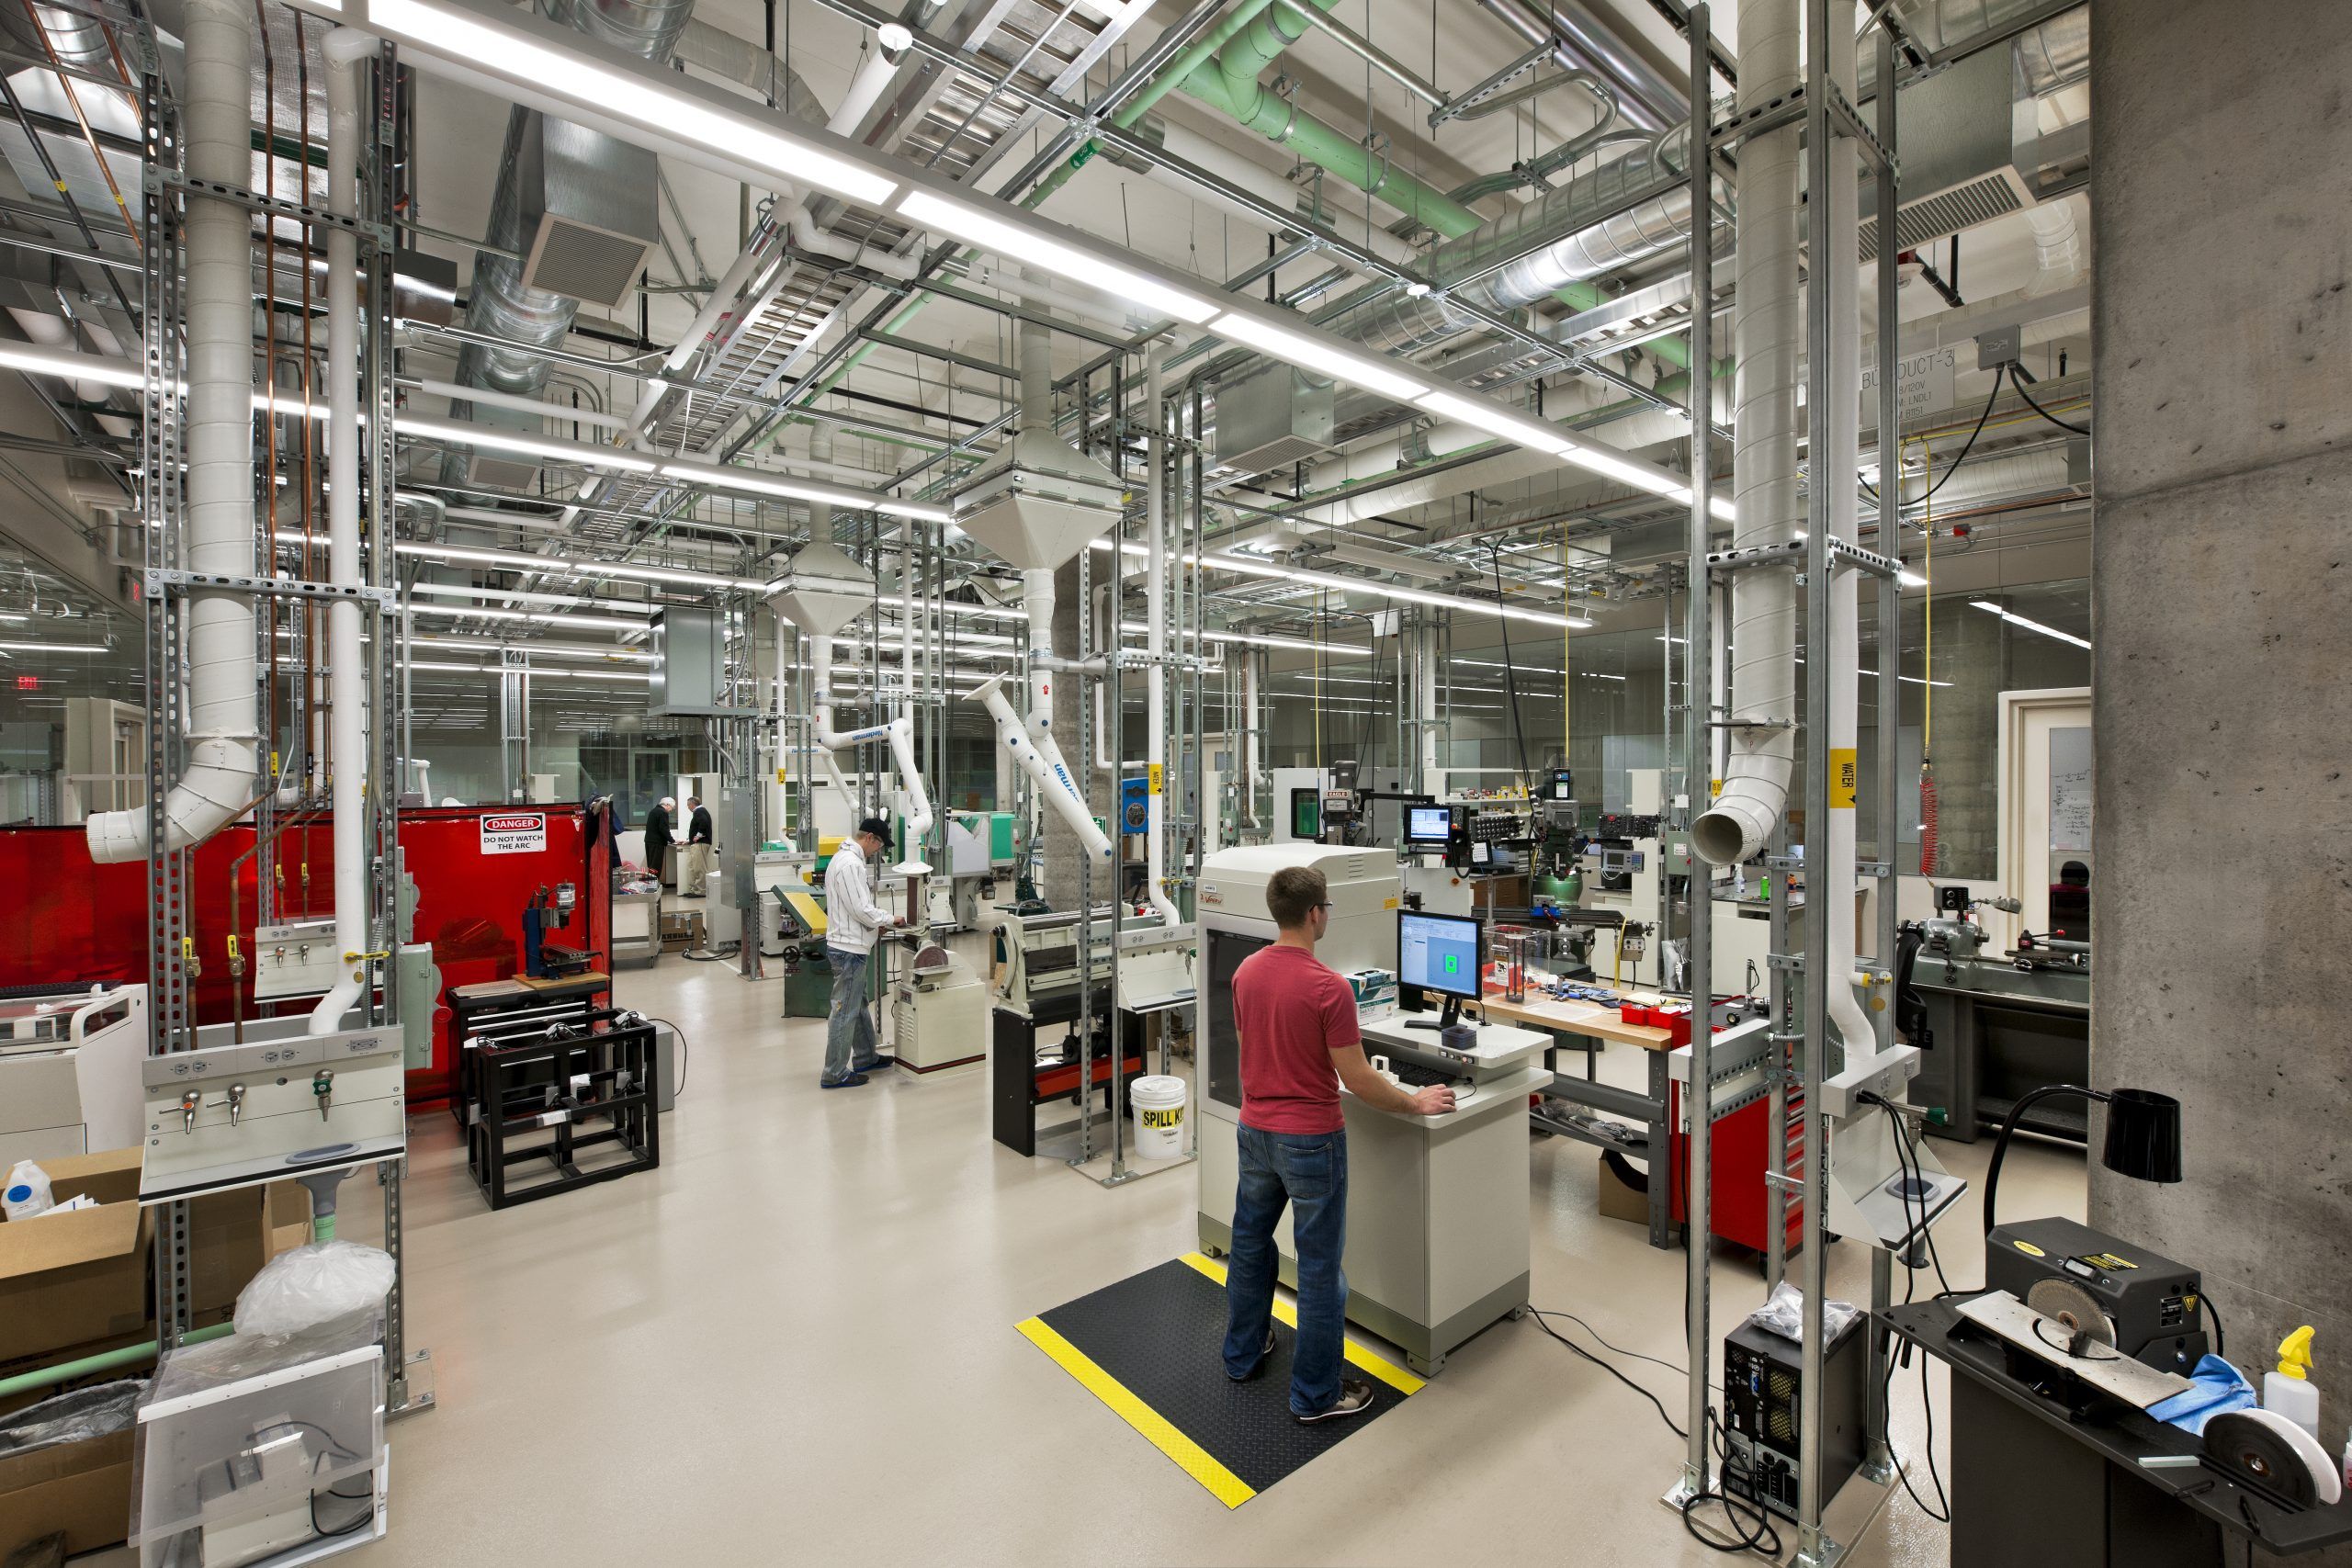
[1722,1314,1870,1518]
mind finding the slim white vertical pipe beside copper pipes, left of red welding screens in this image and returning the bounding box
[311,28,379,1034]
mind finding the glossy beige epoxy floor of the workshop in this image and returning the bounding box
[119,938,2084,1568]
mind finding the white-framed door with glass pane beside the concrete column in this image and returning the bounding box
[1999,686,2098,938]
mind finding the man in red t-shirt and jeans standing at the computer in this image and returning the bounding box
[1226,865,1453,1422]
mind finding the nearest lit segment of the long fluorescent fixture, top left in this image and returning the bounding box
[367,0,899,207]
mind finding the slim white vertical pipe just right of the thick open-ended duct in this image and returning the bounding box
[1806,12,1884,1063]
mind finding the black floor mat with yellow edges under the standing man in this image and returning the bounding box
[1021,1253,1420,1509]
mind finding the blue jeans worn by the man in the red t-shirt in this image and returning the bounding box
[1226,1126,1348,1416]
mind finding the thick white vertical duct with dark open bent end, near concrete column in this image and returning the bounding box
[1691,0,1796,869]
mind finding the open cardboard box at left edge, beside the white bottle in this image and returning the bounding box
[0,1149,149,1361]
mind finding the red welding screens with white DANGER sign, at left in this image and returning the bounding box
[0,807,614,1102]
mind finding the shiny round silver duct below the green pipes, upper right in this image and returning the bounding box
[1334,127,1721,355]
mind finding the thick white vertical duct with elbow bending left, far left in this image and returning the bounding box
[85,0,261,865]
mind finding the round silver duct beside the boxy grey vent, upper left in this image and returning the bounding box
[457,0,694,398]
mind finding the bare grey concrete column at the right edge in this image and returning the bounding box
[2091,0,2352,1438]
